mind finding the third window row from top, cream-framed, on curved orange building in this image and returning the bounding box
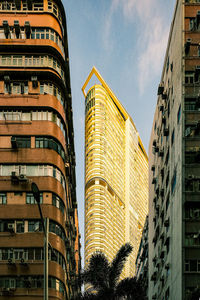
[0,55,65,80]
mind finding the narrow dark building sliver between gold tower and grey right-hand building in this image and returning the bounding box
[135,216,149,295]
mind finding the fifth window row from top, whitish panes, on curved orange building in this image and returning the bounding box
[0,110,66,137]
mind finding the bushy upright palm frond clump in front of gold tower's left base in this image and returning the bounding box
[82,252,110,290]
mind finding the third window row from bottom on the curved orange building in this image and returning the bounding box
[0,219,66,241]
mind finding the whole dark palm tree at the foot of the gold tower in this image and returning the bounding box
[78,243,147,300]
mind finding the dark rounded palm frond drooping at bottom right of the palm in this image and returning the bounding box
[115,277,147,300]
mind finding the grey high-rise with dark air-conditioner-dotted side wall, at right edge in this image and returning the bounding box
[149,0,200,300]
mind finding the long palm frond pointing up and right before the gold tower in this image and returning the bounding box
[109,243,133,287]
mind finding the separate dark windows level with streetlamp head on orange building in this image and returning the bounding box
[0,193,65,214]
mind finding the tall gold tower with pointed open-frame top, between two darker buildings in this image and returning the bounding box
[82,68,148,276]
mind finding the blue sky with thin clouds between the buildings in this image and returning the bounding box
[63,0,176,262]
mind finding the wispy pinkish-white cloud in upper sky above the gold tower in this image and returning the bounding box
[104,0,169,94]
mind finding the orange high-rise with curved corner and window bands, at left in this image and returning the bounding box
[0,0,80,300]
